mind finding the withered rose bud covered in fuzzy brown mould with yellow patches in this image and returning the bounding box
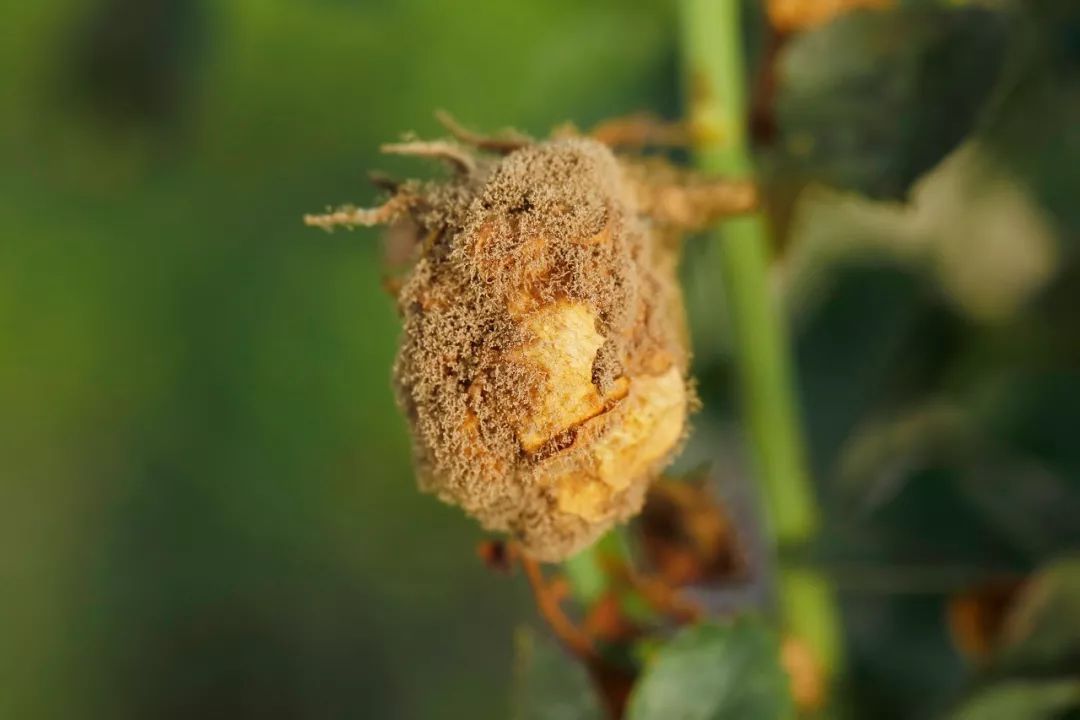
[308,115,755,561]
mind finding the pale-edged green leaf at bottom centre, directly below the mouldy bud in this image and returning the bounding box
[626,619,794,720]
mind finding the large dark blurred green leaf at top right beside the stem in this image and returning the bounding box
[777,6,1004,198]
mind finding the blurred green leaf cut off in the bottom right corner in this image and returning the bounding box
[949,680,1080,720]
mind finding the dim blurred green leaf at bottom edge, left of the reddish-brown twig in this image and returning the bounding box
[512,626,605,720]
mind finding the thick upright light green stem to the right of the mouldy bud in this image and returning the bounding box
[680,0,840,676]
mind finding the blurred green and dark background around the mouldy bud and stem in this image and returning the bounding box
[0,0,1080,719]
